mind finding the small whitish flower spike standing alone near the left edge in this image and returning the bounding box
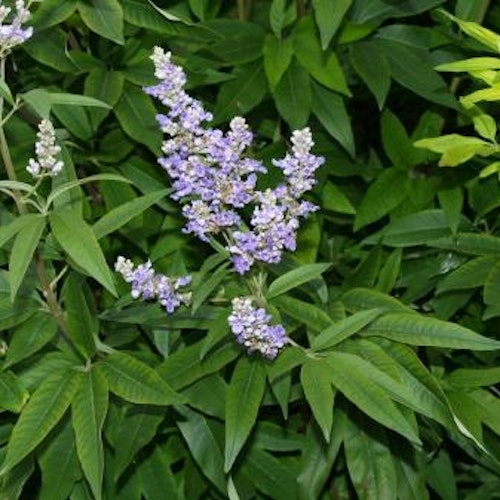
[26,119,64,177]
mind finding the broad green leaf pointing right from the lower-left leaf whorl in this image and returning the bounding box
[98,352,183,406]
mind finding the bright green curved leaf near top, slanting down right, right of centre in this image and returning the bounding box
[293,17,351,96]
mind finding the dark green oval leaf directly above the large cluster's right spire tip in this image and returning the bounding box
[273,60,312,129]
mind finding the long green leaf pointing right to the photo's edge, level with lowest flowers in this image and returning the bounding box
[363,312,500,351]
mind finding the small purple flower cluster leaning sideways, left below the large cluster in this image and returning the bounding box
[115,256,191,314]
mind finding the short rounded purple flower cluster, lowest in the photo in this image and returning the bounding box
[228,297,288,359]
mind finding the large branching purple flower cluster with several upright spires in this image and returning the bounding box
[145,47,323,274]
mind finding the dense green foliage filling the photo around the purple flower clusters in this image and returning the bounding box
[0,0,500,500]
